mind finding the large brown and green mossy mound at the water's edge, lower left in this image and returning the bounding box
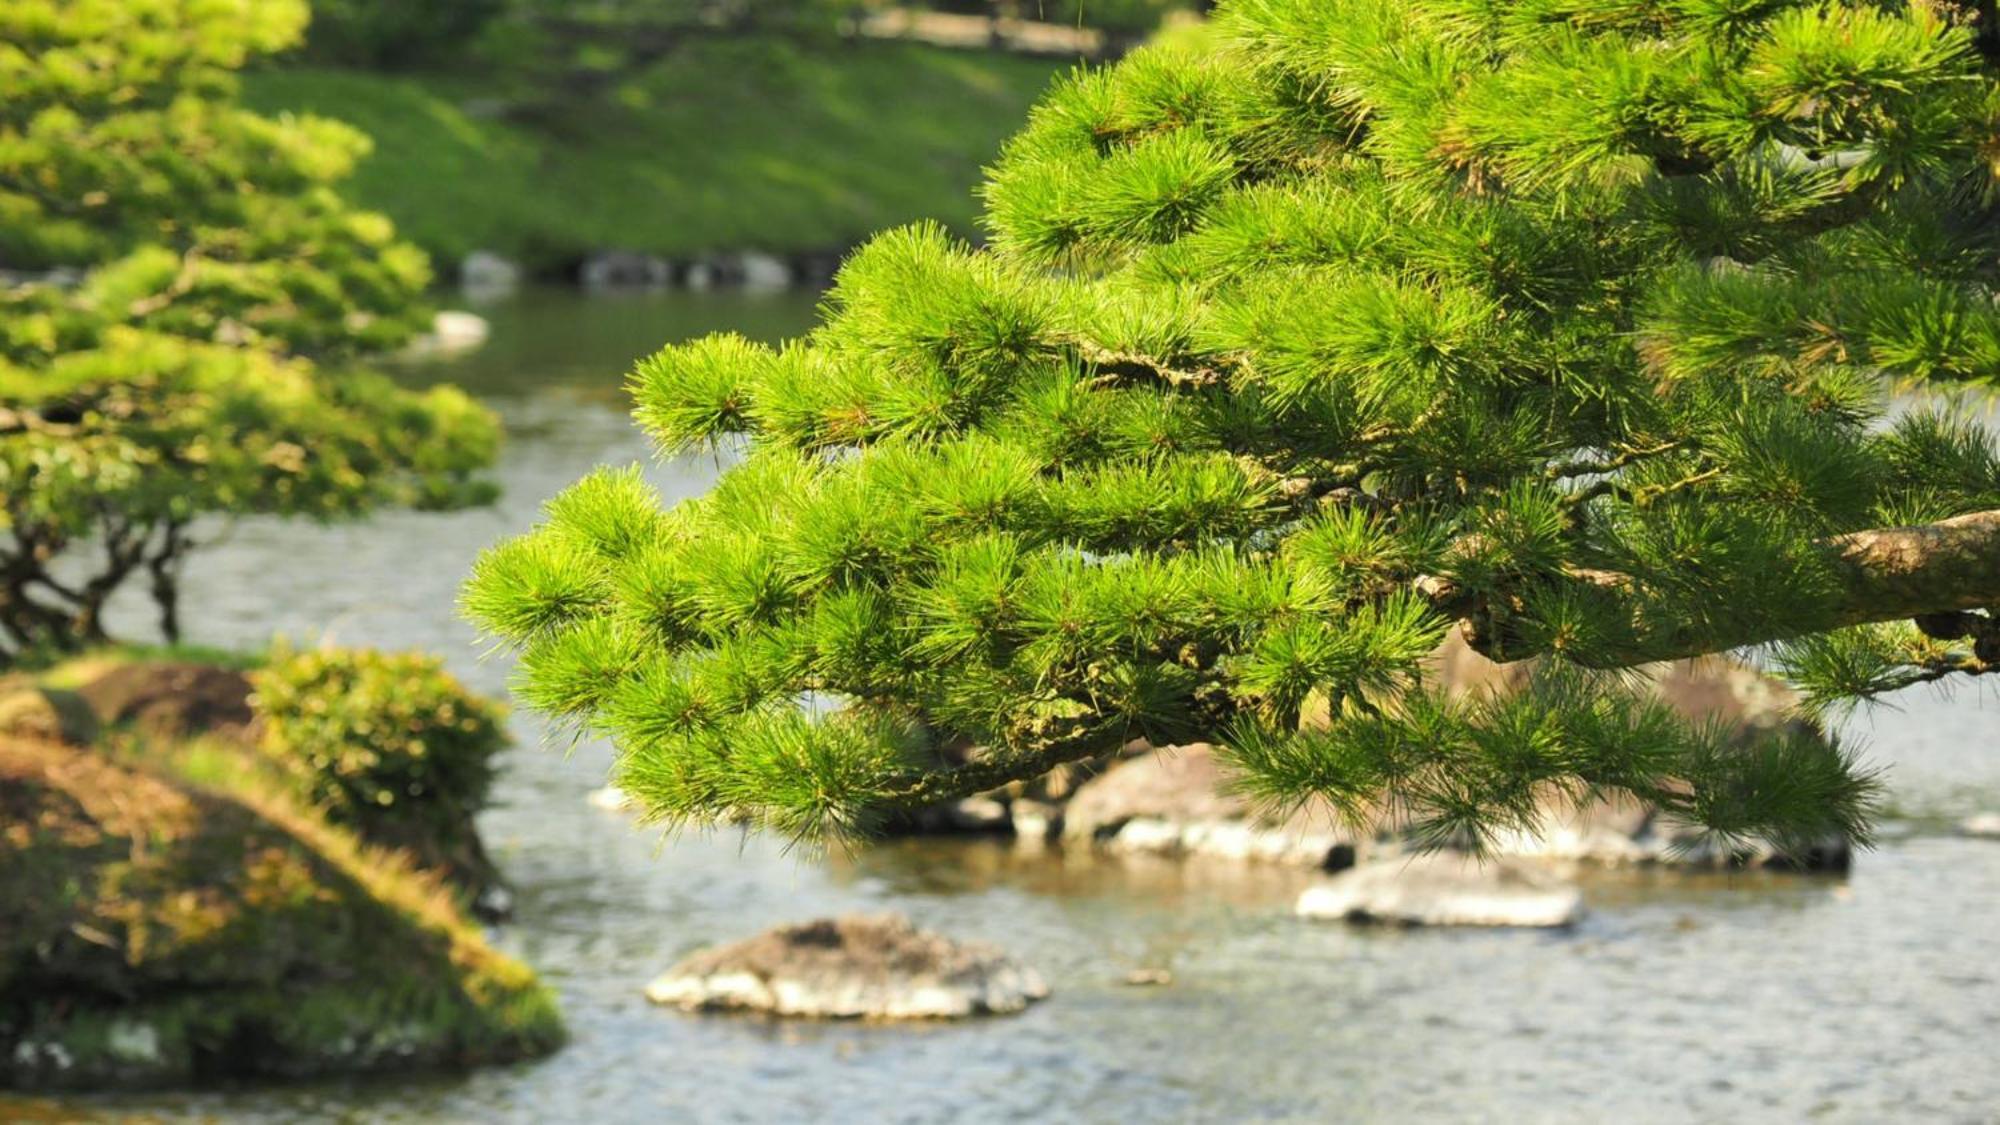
[0,739,562,1089]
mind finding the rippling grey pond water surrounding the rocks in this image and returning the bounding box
[19,292,2000,1123]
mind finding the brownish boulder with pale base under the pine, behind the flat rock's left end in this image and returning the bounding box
[1056,743,1356,867]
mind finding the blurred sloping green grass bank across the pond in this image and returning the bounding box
[244,40,1062,268]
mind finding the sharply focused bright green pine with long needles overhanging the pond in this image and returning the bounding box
[464,0,2000,847]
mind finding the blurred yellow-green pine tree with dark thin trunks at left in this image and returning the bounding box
[0,0,496,661]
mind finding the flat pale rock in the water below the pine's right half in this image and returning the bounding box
[1298,853,1584,927]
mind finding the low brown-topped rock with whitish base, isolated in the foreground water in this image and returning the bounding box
[646,915,1048,1019]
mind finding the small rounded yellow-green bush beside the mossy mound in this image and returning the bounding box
[252,649,506,843]
